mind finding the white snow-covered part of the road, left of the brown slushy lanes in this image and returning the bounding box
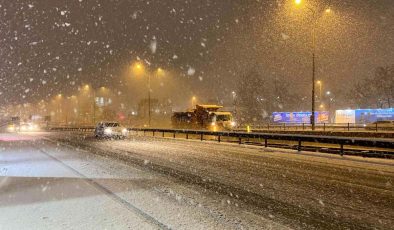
[0,134,287,229]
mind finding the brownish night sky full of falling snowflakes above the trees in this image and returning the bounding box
[0,0,394,104]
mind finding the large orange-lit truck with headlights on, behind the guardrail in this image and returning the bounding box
[171,105,236,131]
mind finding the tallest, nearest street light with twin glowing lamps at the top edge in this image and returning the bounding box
[295,0,331,130]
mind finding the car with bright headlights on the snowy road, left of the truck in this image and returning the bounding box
[94,122,128,138]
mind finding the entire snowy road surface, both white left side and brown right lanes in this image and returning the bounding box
[0,133,394,229]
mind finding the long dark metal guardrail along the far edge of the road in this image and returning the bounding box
[51,127,394,155]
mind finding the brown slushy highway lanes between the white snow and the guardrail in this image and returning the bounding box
[49,133,394,229]
